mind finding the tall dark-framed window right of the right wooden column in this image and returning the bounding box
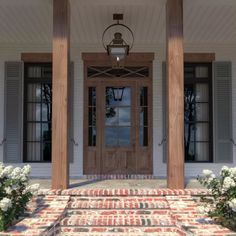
[184,64,212,162]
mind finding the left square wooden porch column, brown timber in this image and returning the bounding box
[52,0,70,189]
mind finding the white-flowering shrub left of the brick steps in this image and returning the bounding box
[0,163,39,231]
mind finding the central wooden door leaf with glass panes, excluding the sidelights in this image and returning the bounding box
[101,81,137,174]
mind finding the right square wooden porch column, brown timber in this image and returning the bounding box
[166,0,184,189]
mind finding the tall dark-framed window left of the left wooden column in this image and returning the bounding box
[24,63,52,162]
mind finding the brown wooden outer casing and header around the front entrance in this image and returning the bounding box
[82,53,154,175]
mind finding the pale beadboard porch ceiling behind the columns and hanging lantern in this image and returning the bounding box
[0,0,236,45]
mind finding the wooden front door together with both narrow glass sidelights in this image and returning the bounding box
[84,53,153,175]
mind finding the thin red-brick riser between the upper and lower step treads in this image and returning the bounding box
[67,209,170,216]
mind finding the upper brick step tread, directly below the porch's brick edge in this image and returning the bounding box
[68,197,169,209]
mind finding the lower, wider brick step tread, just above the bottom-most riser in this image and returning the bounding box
[61,215,175,227]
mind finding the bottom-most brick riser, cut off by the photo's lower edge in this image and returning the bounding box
[61,226,186,236]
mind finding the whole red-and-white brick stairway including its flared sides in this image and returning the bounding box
[0,189,236,236]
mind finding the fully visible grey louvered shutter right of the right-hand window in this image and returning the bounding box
[214,62,233,163]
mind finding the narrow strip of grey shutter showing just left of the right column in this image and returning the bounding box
[162,62,167,162]
